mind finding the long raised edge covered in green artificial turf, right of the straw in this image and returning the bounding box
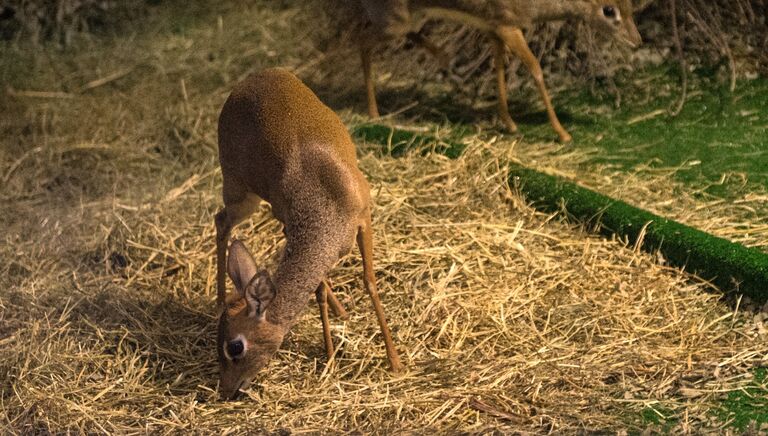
[509,165,768,301]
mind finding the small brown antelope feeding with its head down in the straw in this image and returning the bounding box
[216,69,401,398]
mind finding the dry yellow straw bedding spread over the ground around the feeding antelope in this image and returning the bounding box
[0,0,768,434]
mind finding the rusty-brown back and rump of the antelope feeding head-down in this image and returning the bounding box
[219,68,357,207]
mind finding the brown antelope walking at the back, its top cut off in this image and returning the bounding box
[351,0,642,142]
